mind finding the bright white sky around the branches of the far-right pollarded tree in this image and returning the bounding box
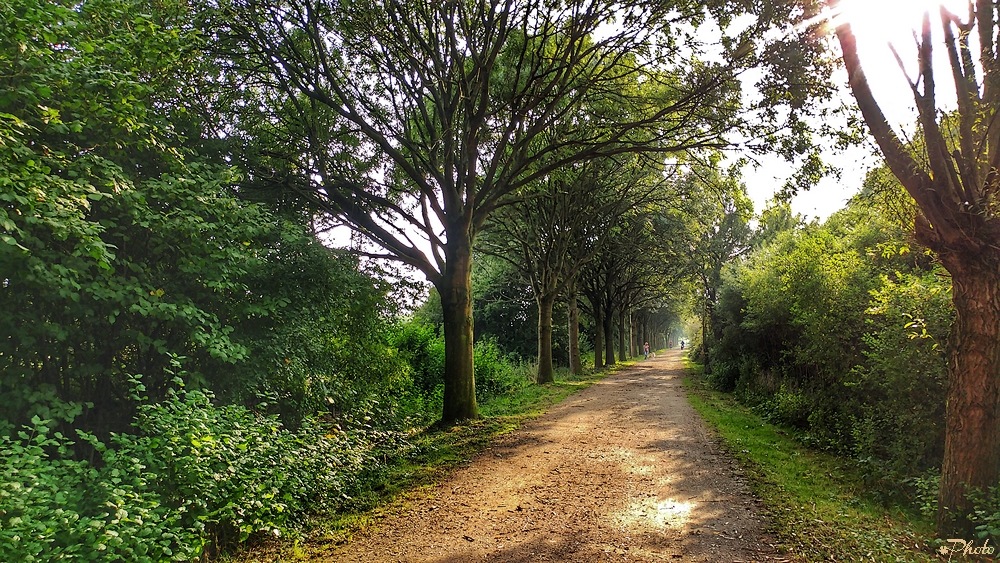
[743,0,975,223]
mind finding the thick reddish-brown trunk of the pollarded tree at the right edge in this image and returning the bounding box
[938,256,1000,538]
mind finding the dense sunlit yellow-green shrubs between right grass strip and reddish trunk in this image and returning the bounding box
[709,200,952,491]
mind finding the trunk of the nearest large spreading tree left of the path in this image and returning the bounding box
[437,241,479,423]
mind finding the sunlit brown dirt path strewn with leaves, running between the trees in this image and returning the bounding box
[328,351,788,563]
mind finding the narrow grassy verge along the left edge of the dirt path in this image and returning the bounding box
[227,361,635,563]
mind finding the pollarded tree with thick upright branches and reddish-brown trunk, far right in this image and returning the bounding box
[829,0,1000,537]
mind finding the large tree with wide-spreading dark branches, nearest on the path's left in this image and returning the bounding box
[212,0,769,422]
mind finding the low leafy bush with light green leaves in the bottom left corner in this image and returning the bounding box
[0,370,401,562]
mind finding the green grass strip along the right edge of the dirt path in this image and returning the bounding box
[685,363,938,562]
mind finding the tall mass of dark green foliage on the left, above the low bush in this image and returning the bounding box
[0,0,404,440]
